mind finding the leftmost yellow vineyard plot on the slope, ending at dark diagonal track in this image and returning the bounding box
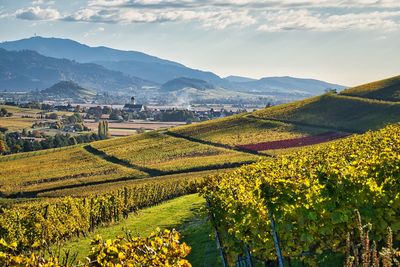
[0,147,148,195]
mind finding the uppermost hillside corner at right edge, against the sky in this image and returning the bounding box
[341,76,400,101]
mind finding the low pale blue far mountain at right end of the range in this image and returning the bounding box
[233,76,346,95]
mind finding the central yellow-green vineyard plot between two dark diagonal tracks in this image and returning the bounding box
[91,132,258,172]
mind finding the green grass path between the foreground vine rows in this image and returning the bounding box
[58,194,218,266]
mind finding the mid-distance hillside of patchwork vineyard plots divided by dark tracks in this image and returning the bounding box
[0,75,400,195]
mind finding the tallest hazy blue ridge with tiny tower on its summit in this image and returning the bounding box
[0,37,227,85]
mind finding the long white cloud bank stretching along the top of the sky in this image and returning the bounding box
[8,0,400,32]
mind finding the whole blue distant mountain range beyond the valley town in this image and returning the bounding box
[0,37,345,102]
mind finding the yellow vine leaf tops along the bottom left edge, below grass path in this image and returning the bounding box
[0,229,191,267]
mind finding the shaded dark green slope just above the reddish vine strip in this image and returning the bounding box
[253,94,400,132]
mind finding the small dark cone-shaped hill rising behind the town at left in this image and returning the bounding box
[40,81,96,99]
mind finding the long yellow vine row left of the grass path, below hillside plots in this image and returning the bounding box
[0,172,204,250]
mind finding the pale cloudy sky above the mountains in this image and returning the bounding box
[0,0,400,85]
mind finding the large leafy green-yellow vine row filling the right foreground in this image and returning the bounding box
[203,125,400,263]
